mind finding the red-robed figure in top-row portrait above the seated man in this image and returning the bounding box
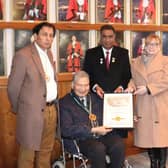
[66,0,88,21]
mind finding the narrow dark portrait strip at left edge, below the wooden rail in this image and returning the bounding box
[0,30,5,75]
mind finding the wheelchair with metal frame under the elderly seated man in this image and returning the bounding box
[52,139,133,168]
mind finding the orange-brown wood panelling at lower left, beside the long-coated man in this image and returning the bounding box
[0,77,18,168]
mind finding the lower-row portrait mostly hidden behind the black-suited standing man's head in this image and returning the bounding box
[96,31,124,47]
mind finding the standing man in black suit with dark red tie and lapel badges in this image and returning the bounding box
[83,25,131,137]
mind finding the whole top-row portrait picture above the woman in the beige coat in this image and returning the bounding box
[131,0,156,24]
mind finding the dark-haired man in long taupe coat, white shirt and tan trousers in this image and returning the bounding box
[8,22,57,168]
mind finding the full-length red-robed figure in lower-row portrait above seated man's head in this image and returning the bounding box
[67,35,83,72]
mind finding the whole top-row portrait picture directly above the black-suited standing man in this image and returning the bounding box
[96,0,124,23]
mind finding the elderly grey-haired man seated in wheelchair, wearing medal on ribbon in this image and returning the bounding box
[59,71,125,168]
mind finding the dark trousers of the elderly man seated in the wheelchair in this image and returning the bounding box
[78,133,125,168]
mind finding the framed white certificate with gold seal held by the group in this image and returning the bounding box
[103,93,133,128]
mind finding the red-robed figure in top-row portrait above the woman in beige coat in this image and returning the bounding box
[136,0,156,24]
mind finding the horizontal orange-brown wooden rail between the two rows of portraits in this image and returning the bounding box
[0,21,168,32]
